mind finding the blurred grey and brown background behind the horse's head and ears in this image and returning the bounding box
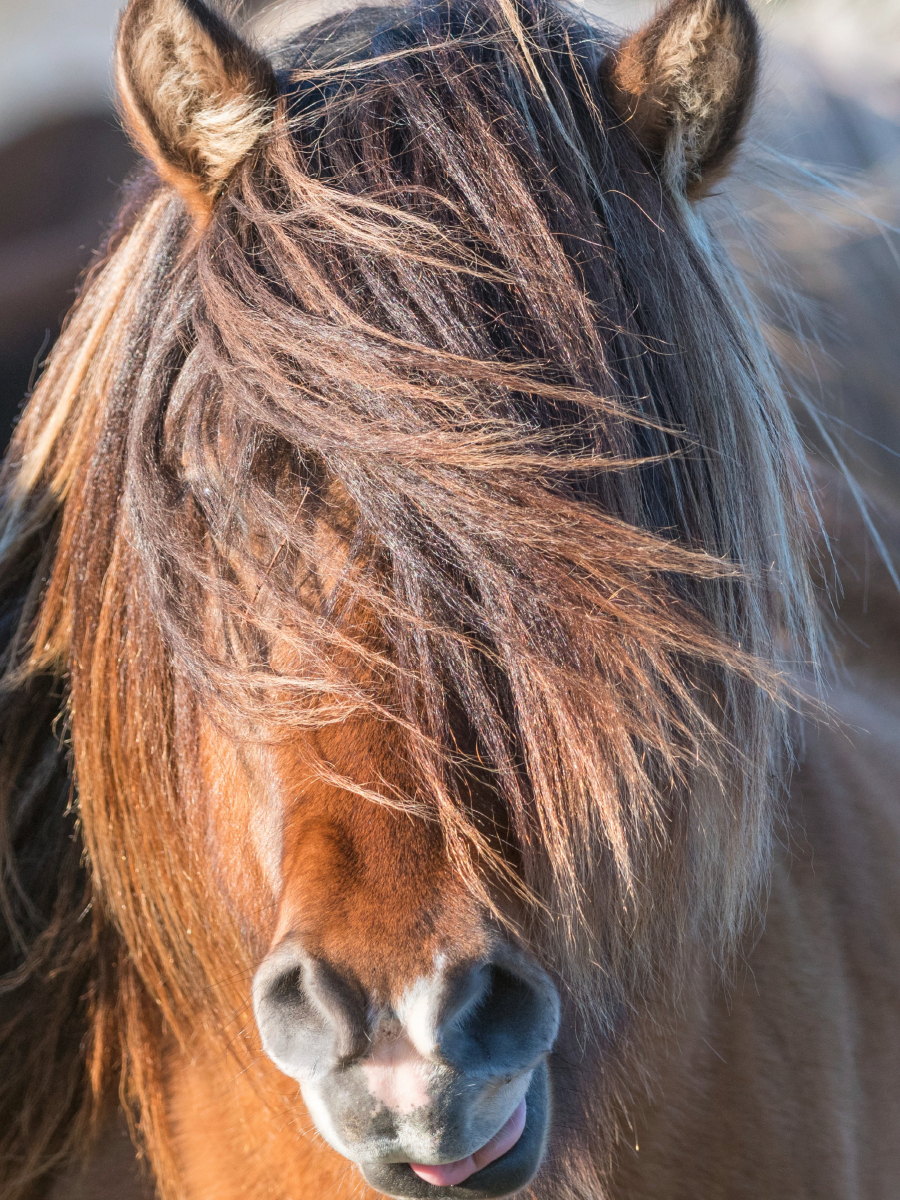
[0,0,900,491]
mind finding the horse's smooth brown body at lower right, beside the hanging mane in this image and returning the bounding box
[616,472,900,1200]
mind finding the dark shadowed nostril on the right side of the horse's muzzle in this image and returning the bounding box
[438,950,559,1075]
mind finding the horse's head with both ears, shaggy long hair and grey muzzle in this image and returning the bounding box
[0,0,815,1198]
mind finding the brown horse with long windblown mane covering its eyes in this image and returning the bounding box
[0,0,900,1200]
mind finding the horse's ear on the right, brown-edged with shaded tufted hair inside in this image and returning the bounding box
[608,0,760,199]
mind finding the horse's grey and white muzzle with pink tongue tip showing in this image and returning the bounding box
[253,938,559,1200]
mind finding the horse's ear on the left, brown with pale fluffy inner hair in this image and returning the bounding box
[116,0,276,224]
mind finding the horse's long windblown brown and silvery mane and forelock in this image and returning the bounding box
[0,0,816,1200]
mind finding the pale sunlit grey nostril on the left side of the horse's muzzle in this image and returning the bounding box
[253,942,368,1079]
